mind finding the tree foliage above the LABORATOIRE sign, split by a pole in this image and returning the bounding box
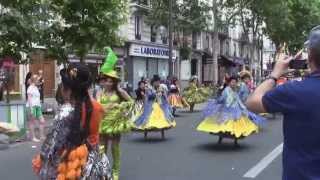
[146,0,209,52]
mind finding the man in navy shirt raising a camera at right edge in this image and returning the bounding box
[247,26,320,180]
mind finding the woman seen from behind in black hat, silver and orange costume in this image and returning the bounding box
[32,65,111,180]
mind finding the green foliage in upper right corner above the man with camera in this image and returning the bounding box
[233,0,320,52]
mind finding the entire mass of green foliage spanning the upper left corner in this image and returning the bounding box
[0,0,128,63]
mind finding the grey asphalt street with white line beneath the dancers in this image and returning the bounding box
[0,105,282,180]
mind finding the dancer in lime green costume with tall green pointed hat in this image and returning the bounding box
[97,48,133,180]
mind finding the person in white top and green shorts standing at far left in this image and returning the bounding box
[27,75,45,142]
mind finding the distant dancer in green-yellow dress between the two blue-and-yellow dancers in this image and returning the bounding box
[183,76,209,112]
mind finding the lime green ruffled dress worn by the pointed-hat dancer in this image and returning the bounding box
[98,93,134,136]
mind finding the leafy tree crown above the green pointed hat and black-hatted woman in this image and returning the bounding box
[43,0,128,62]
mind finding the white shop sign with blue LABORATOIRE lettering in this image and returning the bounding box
[129,44,176,59]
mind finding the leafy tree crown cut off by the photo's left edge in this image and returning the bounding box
[0,0,41,63]
